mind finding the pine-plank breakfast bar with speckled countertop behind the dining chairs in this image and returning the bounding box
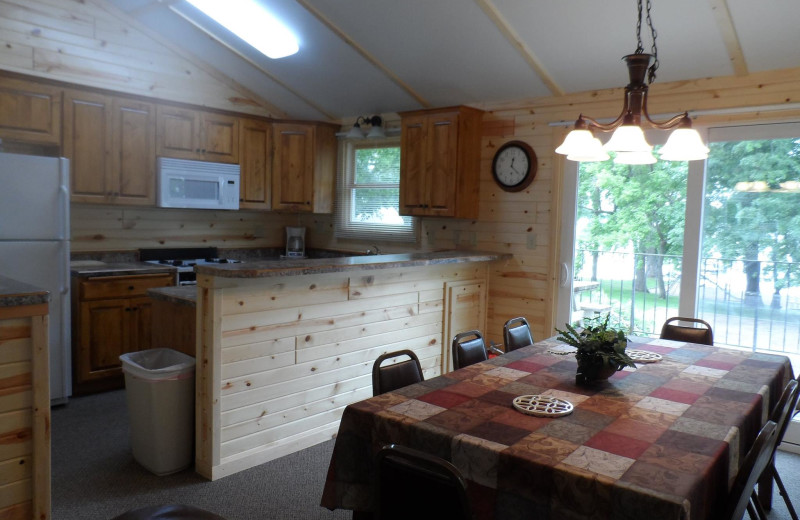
[195,251,511,479]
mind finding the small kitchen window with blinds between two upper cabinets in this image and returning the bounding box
[334,138,418,242]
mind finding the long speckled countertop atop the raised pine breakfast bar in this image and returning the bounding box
[195,251,512,278]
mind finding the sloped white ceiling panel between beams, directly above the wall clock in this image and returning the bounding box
[300,0,549,106]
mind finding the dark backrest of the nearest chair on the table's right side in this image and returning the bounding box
[722,421,778,520]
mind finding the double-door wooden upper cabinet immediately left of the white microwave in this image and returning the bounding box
[63,90,155,205]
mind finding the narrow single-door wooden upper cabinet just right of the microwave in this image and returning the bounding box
[239,118,272,209]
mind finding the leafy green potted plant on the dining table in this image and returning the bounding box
[556,314,636,384]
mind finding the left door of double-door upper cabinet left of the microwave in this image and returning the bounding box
[63,90,114,202]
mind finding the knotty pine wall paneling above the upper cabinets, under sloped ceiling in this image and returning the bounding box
[0,0,270,116]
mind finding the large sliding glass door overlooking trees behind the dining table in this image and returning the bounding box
[556,124,800,358]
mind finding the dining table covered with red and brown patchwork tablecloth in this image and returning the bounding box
[321,336,794,520]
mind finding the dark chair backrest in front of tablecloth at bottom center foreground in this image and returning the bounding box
[376,444,472,520]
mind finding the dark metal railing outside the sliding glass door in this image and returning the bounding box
[573,250,800,354]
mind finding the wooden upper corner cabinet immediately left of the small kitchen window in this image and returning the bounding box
[272,123,337,213]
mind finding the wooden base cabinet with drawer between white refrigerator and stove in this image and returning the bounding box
[72,273,175,395]
